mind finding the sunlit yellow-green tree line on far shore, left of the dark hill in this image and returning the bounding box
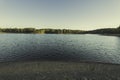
[0,28,84,34]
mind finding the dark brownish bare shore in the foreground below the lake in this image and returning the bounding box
[0,61,120,80]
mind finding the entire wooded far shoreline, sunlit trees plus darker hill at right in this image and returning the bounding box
[0,26,120,34]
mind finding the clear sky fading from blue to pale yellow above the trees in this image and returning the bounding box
[0,0,120,30]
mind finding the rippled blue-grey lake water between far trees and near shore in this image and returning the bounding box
[0,34,120,63]
